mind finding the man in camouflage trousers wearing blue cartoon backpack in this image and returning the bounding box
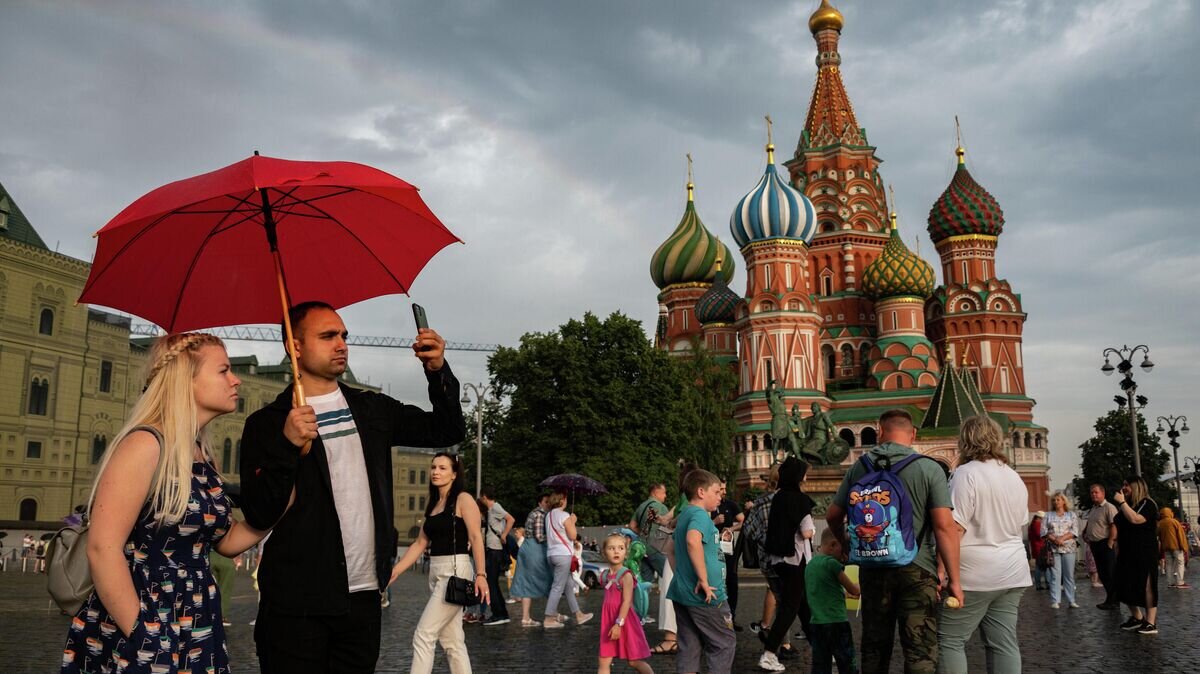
[826,409,962,674]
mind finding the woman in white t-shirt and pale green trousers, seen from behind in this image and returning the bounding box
[937,416,1031,674]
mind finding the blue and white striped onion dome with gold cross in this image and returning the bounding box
[730,145,817,248]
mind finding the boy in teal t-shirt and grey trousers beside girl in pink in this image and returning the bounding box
[667,469,737,674]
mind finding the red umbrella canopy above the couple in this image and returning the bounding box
[79,155,458,332]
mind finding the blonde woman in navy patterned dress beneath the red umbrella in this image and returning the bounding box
[62,332,270,674]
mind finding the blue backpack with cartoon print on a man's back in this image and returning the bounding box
[846,452,929,568]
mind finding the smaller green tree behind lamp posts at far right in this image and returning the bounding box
[1072,410,1175,508]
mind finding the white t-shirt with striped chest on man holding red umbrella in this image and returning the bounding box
[306,389,379,592]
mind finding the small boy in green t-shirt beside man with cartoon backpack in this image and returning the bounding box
[804,529,859,674]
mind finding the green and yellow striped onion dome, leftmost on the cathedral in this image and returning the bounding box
[650,182,733,290]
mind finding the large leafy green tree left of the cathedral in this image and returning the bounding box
[484,313,733,524]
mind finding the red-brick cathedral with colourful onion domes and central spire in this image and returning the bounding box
[650,0,1049,510]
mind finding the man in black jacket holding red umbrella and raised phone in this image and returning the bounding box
[241,302,466,674]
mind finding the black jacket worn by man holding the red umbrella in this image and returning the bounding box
[240,363,466,615]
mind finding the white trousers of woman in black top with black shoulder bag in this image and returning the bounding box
[410,554,475,674]
